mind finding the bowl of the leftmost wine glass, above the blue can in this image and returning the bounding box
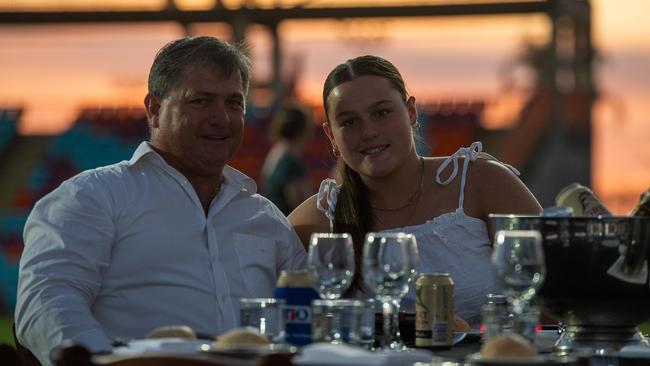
[307,233,354,300]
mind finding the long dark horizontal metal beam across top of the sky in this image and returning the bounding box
[0,0,555,25]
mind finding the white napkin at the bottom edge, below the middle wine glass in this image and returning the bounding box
[293,343,433,366]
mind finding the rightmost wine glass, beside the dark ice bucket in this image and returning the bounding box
[492,230,546,316]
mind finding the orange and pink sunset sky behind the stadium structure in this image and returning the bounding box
[0,0,650,214]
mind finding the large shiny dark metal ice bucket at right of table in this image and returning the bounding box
[490,215,650,348]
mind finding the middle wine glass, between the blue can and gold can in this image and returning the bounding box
[363,233,418,351]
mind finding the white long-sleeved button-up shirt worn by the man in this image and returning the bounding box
[15,142,306,364]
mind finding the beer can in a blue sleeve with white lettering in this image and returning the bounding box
[275,270,319,346]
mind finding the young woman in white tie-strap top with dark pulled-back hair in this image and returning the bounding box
[289,56,541,329]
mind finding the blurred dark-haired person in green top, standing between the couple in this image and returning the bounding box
[262,104,314,215]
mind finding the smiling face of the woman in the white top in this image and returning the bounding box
[323,76,417,177]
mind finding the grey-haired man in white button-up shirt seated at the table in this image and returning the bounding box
[15,37,306,364]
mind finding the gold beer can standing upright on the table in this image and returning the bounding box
[415,273,454,348]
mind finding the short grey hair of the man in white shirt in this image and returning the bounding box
[148,36,251,99]
